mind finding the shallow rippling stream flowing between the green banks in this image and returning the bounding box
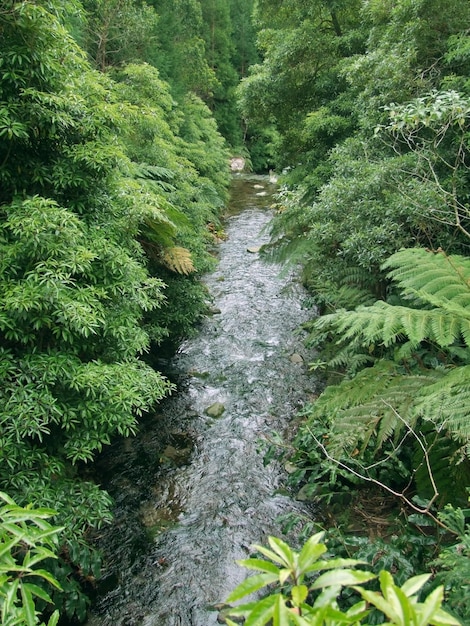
[88,175,314,626]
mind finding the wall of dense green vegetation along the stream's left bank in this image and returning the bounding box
[0,0,242,623]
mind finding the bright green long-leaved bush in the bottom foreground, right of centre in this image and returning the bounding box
[226,533,460,626]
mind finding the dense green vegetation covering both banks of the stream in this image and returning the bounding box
[0,0,470,624]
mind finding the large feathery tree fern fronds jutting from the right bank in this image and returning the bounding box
[302,244,470,502]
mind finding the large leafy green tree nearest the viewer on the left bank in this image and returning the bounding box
[0,2,171,560]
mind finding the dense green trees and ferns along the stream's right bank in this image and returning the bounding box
[239,0,470,623]
